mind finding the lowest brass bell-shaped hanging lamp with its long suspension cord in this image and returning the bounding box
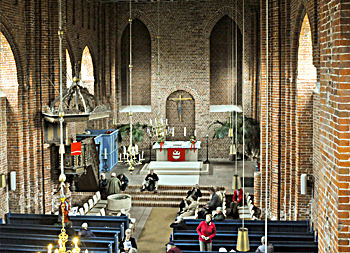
[236,0,250,252]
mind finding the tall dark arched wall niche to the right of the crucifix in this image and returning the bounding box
[210,15,242,105]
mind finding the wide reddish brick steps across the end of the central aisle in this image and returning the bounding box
[123,185,223,207]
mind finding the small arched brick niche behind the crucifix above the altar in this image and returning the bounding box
[166,90,196,141]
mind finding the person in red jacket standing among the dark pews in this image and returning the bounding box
[197,214,216,251]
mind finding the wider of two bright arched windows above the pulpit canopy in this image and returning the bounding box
[81,46,95,94]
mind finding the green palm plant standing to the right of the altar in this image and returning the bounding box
[208,113,260,158]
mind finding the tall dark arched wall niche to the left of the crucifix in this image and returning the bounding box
[120,18,152,106]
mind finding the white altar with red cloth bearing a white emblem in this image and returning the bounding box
[152,141,201,162]
